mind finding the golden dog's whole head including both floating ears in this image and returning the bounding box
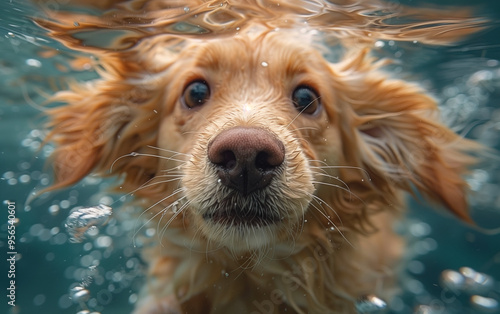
[46,31,474,255]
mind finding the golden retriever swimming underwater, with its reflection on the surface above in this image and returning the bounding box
[37,1,486,313]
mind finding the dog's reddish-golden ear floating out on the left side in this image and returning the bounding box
[46,80,157,190]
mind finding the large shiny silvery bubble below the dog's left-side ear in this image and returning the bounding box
[65,204,112,243]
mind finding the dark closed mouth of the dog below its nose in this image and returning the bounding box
[203,207,282,228]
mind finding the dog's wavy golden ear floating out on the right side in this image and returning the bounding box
[334,51,480,222]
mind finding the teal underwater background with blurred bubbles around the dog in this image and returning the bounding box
[0,0,500,314]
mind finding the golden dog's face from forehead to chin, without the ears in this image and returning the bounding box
[158,34,340,250]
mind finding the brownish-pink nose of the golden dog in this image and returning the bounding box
[207,127,285,195]
